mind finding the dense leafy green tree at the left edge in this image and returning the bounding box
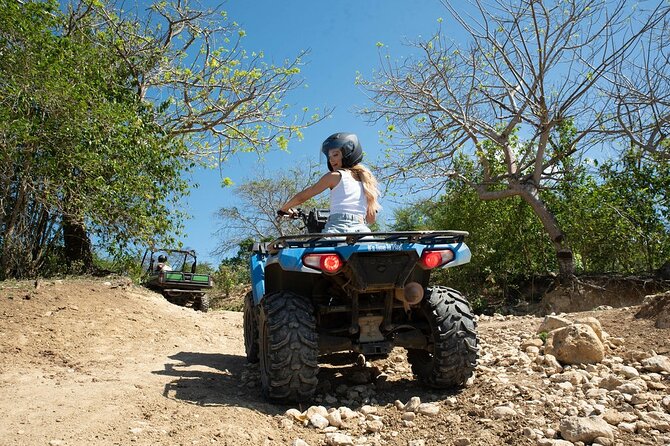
[0,2,187,277]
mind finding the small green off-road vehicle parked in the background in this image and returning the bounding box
[142,248,214,312]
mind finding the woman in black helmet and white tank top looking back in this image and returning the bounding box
[278,133,381,233]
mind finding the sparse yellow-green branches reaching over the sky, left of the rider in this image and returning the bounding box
[70,0,330,163]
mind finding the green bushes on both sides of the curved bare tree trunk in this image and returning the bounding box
[394,152,670,310]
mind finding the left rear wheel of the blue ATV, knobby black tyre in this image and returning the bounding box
[259,291,319,403]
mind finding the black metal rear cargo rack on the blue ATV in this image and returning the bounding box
[252,231,469,254]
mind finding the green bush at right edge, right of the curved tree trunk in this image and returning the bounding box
[555,151,670,273]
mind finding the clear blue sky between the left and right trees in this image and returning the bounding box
[183,0,460,265]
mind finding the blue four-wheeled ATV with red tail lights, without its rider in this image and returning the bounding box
[244,210,478,402]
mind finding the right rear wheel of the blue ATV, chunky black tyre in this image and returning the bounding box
[407,287,478,388]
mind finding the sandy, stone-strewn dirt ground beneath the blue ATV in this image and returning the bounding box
[0,279,670,446]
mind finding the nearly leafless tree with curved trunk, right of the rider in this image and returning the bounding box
[360,0,668,277]
